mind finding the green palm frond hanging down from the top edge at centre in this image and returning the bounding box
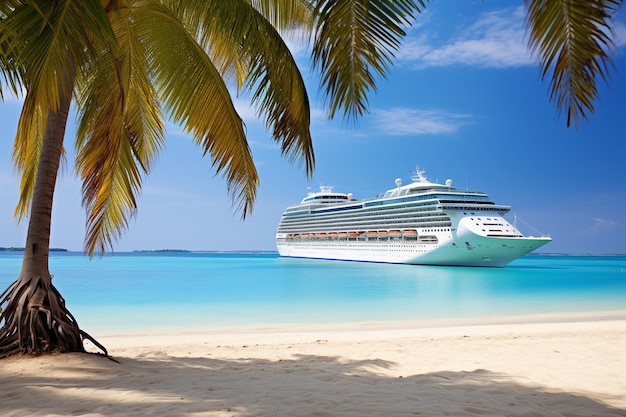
[313,0,424,119]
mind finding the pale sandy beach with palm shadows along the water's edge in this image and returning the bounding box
[0,312,626,417]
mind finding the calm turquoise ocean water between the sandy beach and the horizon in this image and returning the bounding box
[0,252,626,335]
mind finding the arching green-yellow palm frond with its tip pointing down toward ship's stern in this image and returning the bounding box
[184,0,315,175]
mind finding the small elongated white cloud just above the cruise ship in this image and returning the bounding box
[372,107,470,136]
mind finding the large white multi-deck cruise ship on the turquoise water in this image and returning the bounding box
[276,167,552,267]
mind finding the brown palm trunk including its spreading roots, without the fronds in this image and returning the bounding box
[0,61,107,358]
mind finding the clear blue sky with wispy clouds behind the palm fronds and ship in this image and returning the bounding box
[0,0,626,253]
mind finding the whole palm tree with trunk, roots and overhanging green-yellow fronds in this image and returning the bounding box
[0,0,423,357]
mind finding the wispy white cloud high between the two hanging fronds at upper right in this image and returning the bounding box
[398,7,534,69]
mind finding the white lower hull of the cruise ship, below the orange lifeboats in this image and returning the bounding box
[277,231,551,267]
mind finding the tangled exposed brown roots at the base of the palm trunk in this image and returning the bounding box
[0,277,109,358]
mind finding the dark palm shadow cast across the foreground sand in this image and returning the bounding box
[0,354,626,417]
